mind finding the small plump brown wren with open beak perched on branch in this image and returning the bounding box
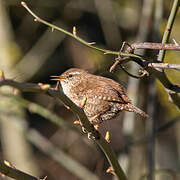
[52,68,148,125]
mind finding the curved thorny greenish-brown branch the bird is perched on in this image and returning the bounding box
[0,77,127,180]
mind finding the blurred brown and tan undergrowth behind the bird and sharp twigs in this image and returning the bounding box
[0,0,180,180]
